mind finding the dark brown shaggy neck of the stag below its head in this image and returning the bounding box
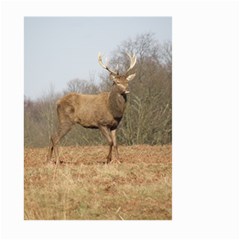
[109,85,127,119]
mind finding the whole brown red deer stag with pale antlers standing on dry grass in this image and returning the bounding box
[47,53,137,164]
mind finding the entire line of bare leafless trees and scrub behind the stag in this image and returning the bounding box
[24,33,172,147]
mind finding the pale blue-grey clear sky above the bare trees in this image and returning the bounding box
[24,17,172,99]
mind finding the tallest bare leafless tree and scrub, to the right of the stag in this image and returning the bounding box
[103,33,172,145]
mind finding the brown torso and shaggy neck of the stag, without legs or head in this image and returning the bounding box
[57,85,127,130]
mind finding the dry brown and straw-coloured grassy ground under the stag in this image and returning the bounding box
[24,145,172,220]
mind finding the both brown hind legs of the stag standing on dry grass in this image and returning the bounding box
[47,122,73,164]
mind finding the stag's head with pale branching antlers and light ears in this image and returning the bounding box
[98,53,137,94]
